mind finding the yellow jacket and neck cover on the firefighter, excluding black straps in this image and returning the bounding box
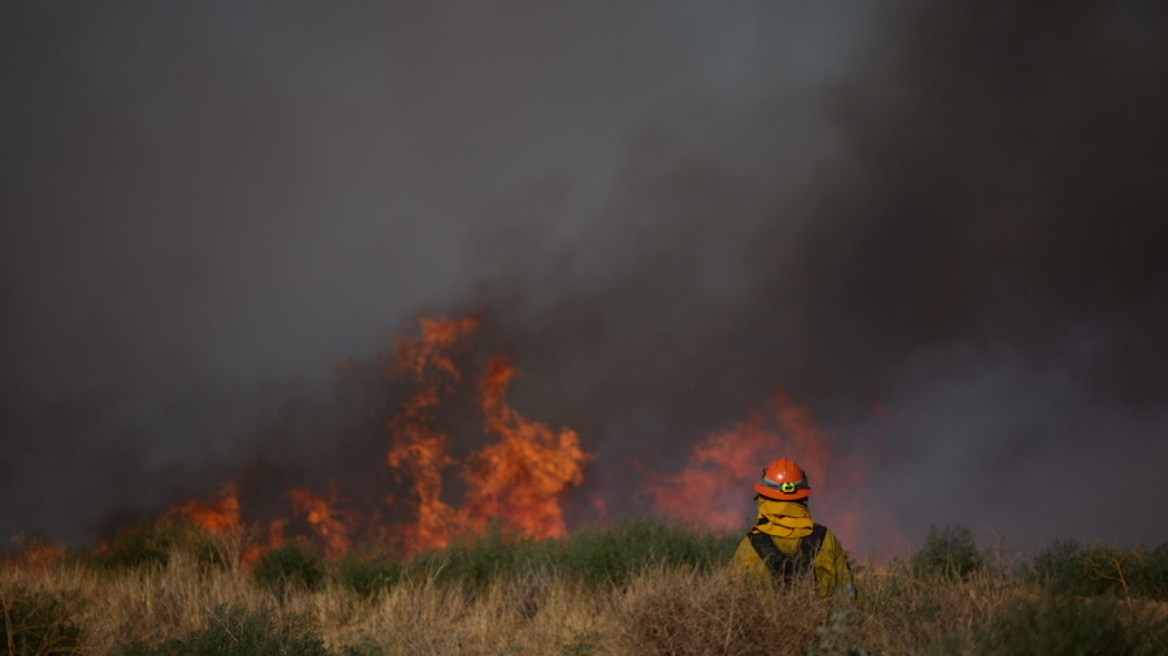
[731,497,856,596]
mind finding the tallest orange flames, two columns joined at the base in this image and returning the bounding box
[387,319,588,552]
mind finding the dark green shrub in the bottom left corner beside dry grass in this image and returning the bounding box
[0,586,82,656]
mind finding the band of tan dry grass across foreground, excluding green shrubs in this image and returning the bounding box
[0,543,1168,656]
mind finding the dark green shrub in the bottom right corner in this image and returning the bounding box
[973,596,1168,656]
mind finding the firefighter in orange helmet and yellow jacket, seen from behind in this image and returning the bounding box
[732,458,856,598]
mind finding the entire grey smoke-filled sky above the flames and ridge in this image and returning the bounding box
[0,0,1168,553]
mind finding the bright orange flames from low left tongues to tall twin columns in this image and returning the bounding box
[162,316,530,565]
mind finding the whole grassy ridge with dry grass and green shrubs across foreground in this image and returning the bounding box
[0,519,1168,656]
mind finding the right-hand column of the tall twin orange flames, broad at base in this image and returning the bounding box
[463,356,589,538]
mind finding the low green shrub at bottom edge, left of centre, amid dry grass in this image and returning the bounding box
[118,605,329,656]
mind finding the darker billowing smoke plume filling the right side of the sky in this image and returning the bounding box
[455,2,1168,543]
